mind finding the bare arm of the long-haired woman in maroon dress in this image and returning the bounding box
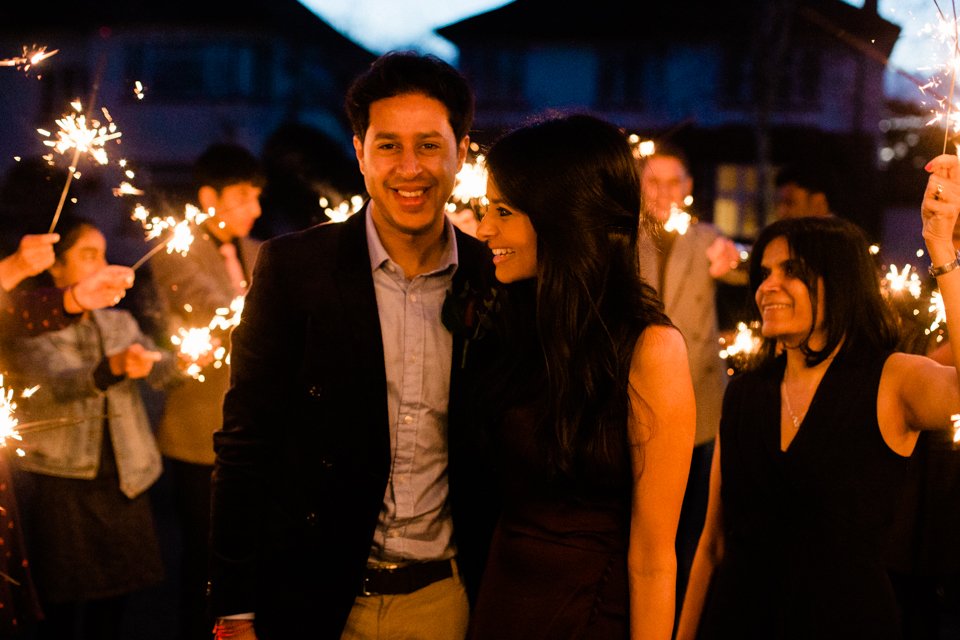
[627,326,696,640]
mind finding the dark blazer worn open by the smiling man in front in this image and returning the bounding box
[209,210,494,640]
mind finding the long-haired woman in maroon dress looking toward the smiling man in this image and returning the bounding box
[471,115,695,639]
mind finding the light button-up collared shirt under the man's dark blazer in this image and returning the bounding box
[366,209,458,562]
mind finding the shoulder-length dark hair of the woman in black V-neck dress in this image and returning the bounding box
[750,217,899,367]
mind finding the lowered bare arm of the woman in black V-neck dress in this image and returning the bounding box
[677,436,723,640]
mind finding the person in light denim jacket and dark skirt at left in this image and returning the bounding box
[11,218,178,640]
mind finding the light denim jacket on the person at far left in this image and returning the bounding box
[13,309,177,498]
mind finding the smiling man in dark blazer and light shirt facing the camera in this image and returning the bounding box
[211,53,492,640]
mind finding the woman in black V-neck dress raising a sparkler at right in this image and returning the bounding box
[678,156,960,640]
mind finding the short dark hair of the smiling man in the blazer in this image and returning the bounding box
[344,51,474,141]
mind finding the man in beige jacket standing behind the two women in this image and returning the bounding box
[638,142,746,613]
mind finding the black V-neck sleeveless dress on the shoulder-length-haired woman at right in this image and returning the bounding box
[698,354,909,640]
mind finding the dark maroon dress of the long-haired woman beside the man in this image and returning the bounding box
[468,406,631,640]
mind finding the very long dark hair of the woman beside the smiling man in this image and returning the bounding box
[487,115,670,478]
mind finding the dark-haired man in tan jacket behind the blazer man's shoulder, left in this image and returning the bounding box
[151,143,265,640]
